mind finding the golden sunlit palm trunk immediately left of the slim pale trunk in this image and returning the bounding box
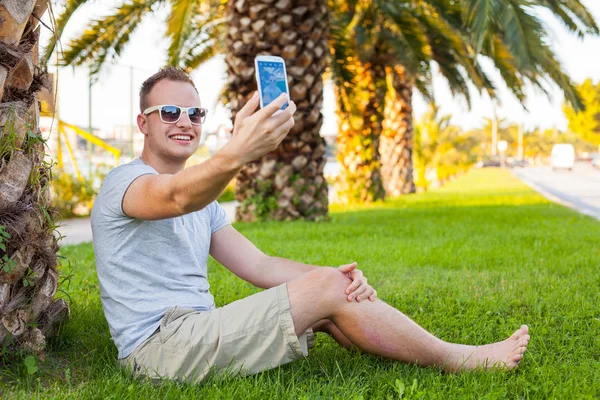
[336,52,385,204]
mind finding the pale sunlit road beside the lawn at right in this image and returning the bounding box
[512,163,600,219]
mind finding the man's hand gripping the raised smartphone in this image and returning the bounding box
[222,92,296,166]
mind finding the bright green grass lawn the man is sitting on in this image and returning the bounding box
[0,170,600,399]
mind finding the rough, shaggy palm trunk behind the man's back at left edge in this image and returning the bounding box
[0,0,69,356]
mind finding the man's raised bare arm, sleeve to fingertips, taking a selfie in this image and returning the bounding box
[123,93,296,220]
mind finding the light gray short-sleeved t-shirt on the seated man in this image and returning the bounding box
[92,159,229,358]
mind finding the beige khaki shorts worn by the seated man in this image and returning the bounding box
[119,283,314,382]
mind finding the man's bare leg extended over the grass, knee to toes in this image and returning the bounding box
[288,268,529,371]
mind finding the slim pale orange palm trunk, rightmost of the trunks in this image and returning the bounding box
[379,66,416,196]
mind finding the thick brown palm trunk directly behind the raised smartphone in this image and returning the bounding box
[225,0,329,221]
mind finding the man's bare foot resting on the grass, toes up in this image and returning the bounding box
[446,325,530,371]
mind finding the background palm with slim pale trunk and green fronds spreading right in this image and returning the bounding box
[337,0,598,200]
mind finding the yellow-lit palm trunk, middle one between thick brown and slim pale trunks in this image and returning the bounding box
[329,10,385,203]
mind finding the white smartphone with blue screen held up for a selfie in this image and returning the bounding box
[254,56,290,114]
